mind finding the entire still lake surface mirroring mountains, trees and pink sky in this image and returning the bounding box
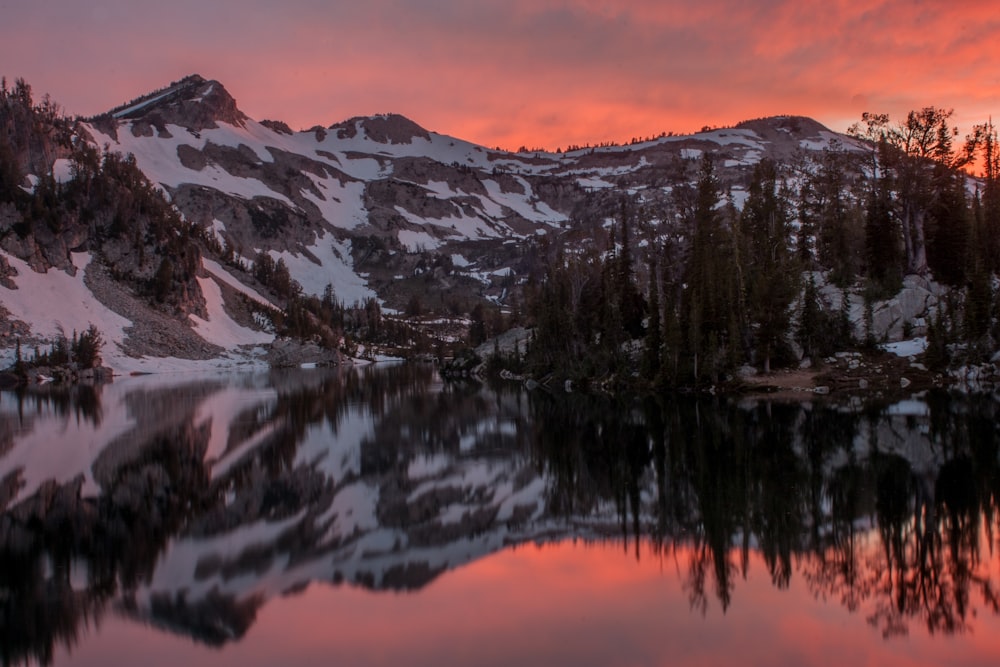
[0,365,1000,667]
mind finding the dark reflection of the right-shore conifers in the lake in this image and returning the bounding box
[532,393,1000,636]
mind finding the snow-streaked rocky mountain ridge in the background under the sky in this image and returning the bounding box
[84,76,848,307]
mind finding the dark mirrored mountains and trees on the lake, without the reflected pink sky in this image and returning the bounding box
[0,365,1000,664]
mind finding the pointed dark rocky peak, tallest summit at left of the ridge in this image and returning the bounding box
[106,74,248,131]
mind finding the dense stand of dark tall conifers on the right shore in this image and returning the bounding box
[517,108,1000,386]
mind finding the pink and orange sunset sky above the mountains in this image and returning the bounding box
[0,0,1000,154]
